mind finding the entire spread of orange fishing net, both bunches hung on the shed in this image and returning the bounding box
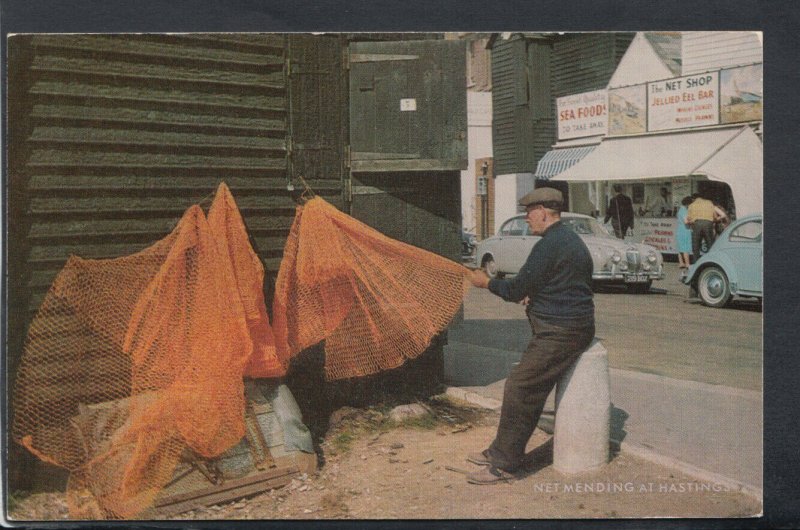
[12,183,468,519]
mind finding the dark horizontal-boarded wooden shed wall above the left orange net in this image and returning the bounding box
[12,35,293,318]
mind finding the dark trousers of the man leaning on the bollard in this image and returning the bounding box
[488,317,595,472]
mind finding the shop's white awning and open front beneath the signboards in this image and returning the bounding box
[551,125,763,254]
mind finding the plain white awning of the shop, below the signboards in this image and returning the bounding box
[552,126,764,217]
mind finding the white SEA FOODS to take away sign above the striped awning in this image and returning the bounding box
[556,90,608,140]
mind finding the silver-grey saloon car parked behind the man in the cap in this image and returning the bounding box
[475,212,664,293]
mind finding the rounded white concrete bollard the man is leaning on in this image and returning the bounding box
[553,339,611,474]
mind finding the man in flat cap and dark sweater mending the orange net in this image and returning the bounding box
[467,188,595,484]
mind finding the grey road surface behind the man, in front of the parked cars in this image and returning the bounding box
[449,263,763,390]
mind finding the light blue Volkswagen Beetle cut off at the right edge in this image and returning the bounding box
[683,214,764,307]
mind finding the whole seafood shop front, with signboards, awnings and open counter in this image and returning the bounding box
[536,63,763,254]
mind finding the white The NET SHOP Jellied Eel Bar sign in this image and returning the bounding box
[647,72,719,131]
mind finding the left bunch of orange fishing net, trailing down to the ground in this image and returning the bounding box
[12,184,285,518]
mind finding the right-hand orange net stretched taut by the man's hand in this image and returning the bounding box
[273,197,470,380]
